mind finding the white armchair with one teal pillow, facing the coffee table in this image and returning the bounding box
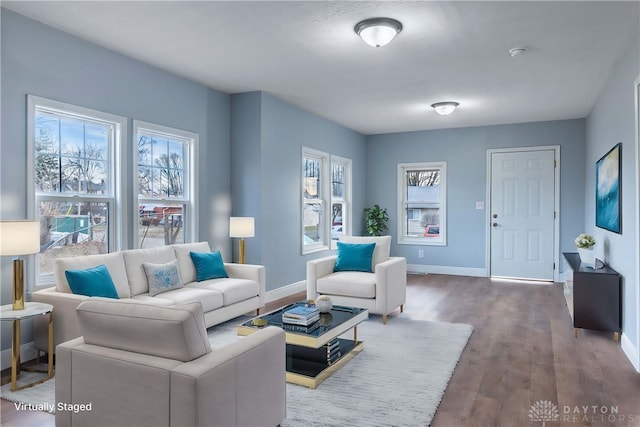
[307,236,407,324]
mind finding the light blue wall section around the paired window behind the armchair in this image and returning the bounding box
[231,92,366,290]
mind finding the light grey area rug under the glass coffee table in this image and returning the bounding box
[0,314,473,427]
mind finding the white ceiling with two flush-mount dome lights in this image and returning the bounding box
[2,1,640,134]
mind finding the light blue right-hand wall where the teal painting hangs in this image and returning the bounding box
[584,30,640,369]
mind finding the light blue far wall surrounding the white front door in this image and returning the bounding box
[367,119,585,269]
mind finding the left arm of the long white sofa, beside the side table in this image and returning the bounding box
[31,286,90,352]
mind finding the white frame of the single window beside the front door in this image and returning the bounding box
[397,161,447,246]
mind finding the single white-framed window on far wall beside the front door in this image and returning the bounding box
[398,162,447,246]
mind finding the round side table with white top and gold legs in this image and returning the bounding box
[0,302,53,391]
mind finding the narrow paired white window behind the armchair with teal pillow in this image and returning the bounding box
[302,148,351,254]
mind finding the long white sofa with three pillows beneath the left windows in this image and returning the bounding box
[31,242,265,351]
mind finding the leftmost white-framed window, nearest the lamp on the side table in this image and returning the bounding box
[27,96,126,284]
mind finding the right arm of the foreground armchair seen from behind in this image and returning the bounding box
[169,327,286,426]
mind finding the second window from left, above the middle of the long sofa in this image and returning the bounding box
[134,120,198,248]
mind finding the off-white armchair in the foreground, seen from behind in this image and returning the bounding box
[56,299,286,427]
